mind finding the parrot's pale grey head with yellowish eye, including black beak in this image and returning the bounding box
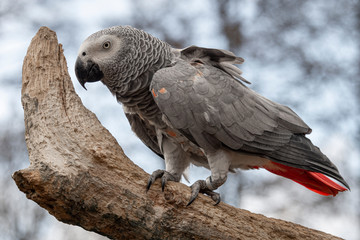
[75,26,134,89]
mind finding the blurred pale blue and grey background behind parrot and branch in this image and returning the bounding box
[0,0,360,240]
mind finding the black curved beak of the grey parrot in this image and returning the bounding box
[75,57,104,90]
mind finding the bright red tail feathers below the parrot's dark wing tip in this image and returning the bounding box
[264,162,347,196]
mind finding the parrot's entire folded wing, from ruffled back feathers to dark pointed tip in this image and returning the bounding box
[150,46,347,186]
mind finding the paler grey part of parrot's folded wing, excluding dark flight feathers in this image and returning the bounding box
[151,59,310,151]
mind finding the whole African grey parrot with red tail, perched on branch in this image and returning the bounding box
[75,26,349,205]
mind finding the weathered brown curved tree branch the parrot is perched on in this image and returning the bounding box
[13,27,344,239]
